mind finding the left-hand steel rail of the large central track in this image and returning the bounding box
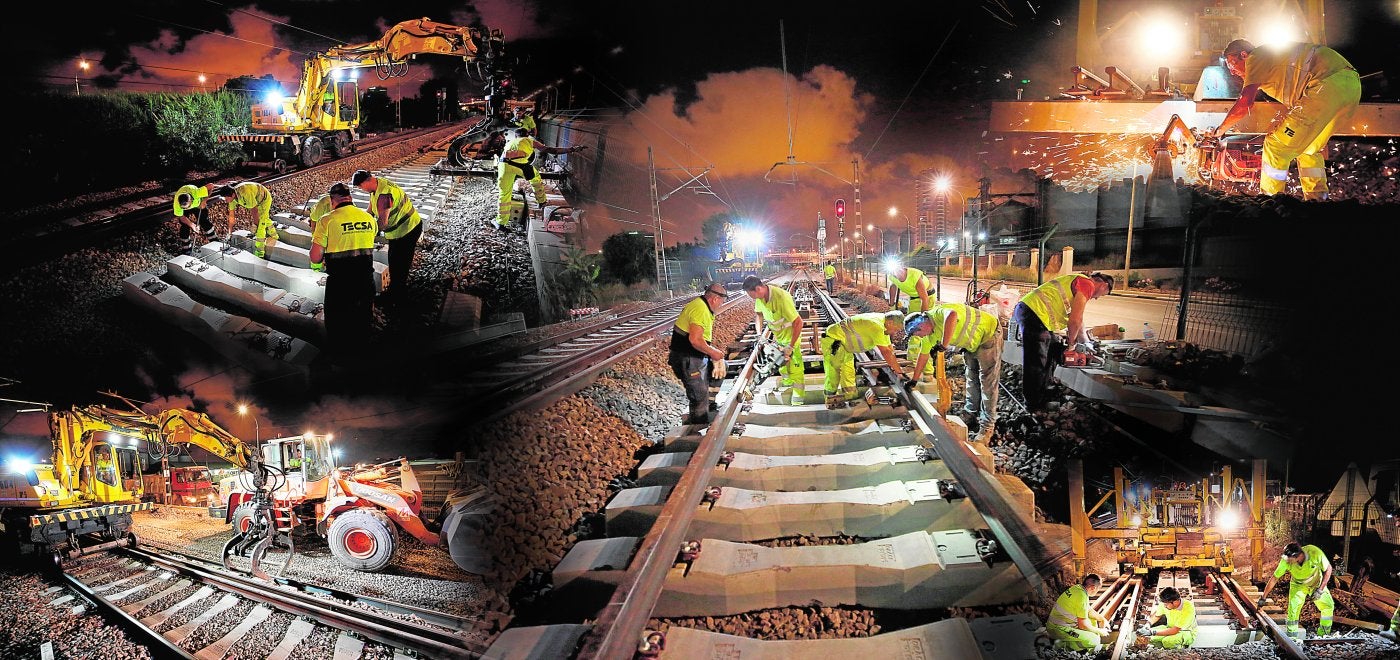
[575,305,769,660]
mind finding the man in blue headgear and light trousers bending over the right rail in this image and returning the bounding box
[904,303,1005,443]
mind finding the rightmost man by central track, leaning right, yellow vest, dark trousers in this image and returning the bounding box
[1011,273,1113,412]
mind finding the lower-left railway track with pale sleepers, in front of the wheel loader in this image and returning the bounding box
[56,548,484,659]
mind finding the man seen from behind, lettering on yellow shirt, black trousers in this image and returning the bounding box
[311,182,379,359]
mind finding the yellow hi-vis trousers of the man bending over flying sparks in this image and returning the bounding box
[1259,69,1361,199]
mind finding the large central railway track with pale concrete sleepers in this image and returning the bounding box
[476,276,1063,659]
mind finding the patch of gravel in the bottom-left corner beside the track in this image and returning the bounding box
[0,570,151,660]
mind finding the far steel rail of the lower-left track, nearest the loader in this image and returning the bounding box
[109,548,486,657]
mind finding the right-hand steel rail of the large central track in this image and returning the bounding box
[813,287,1063,598]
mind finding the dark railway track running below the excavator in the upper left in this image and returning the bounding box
[0,125,463,275]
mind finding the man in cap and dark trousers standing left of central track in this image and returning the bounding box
[666,282,728,425]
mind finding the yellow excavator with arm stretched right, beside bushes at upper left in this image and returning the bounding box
[218,18,508,172]
